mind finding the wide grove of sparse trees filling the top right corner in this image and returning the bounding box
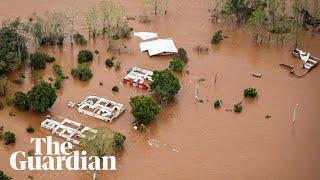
[210,0,320,46]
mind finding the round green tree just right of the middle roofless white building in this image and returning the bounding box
[130,96,159,125]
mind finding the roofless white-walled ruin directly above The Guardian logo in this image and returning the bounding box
[41,116,98,144]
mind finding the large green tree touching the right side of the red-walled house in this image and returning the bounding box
[150,69,181,105]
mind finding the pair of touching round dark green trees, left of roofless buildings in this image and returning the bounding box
[11,82,57,112]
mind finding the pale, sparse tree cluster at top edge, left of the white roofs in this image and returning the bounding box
[85,0,132,39]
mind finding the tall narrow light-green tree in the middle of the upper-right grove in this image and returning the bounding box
[248,8,266,43]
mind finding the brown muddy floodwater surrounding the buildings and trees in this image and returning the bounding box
[0,0,320,180]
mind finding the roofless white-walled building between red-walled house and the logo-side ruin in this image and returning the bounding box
[78,96,125,122]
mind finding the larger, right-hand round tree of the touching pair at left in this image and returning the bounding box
[27,82,57,112]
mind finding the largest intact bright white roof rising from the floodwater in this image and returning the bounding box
[140,39,178,56]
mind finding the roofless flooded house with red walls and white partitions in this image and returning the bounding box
[123,67,153,90]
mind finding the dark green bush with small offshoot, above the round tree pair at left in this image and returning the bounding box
[30,52,55,69]
